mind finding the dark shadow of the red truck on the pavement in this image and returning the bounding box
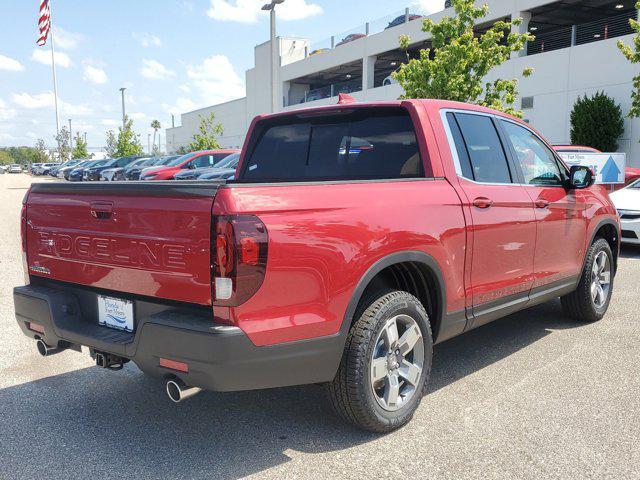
[0,302,578,479]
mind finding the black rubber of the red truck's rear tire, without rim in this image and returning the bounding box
[327,291,433,433]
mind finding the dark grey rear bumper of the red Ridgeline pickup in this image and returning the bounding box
[14,286,344,391]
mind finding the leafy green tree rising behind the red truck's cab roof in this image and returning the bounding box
[393,0,534,117]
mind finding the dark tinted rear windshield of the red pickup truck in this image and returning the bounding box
[242,108,424,182]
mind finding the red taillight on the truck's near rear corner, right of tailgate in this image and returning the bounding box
[211,215,269,306]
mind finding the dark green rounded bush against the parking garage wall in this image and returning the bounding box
[571,92,624,152]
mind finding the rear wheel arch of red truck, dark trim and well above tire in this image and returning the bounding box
[341,250,447,342]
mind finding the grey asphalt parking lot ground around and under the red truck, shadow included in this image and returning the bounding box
[0,174,640,479]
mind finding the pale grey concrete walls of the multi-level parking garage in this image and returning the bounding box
[166,0,640,167]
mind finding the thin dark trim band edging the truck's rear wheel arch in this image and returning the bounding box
[340,250,447,341]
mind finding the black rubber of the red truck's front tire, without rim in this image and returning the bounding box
[560,238,615,323]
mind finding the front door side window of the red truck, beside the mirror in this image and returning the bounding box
[501,120,564,186]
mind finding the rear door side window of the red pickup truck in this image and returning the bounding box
[455,113,512,183]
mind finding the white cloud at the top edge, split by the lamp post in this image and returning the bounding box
[207,0,323,23]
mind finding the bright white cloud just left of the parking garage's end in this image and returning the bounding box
[187,55,245,105]
